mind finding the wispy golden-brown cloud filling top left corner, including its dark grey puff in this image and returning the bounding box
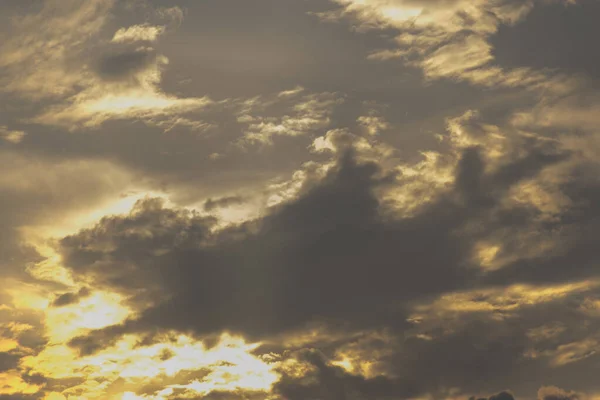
[0,0,210,131]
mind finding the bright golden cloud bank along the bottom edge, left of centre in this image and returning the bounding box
[23,332,277,400]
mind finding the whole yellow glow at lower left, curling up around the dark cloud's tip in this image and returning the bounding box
[0,192,290,400]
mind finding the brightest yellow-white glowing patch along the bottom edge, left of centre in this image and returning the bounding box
[23,334,278,399]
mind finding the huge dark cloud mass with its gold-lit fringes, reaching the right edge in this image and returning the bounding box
[38,97,597,398]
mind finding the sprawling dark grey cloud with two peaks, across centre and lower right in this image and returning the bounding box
[56,130,593,398]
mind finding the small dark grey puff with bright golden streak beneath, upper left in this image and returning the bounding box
[33,36,213,131]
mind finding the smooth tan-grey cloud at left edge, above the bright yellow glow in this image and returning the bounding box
[0,150,136,282]
